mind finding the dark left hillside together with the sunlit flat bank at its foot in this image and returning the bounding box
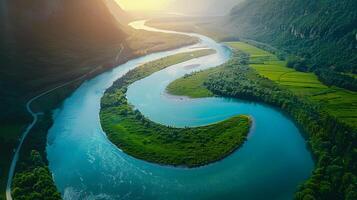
[0,0,197,199]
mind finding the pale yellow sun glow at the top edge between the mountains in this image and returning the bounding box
[116,0,170,11]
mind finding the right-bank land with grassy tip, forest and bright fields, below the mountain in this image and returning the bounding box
[167,42,357,199]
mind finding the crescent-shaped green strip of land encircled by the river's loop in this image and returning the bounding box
[100,50,251,167]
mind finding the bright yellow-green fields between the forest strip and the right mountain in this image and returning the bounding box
[227,42,357,128]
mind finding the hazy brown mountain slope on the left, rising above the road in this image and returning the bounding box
[0,0,127,121]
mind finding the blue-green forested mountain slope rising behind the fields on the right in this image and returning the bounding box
[228,0,357,90]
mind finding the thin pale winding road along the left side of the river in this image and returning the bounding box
[6,44,124,200]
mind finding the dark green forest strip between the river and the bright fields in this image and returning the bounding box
[200,51,357,200]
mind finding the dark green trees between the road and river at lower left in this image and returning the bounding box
[11,113,61,200]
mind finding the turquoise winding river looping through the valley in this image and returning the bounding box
[47,21,314,200]
